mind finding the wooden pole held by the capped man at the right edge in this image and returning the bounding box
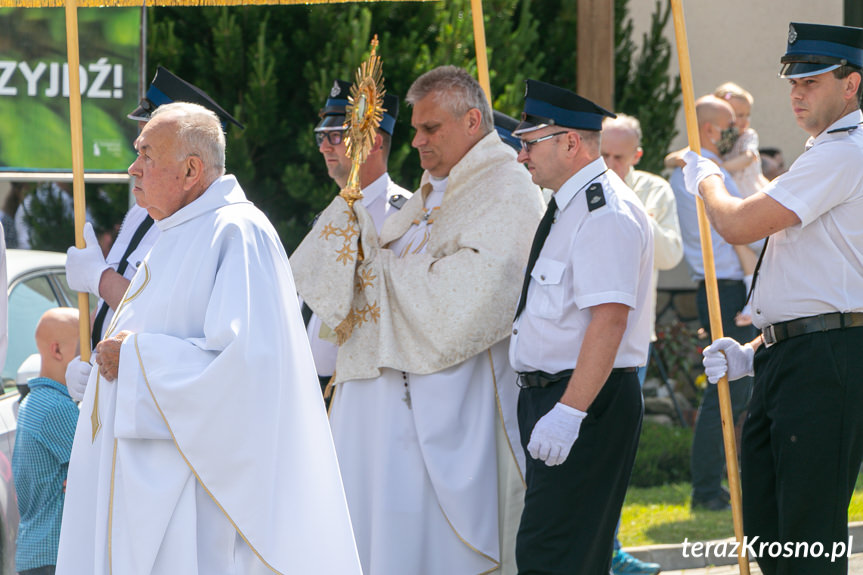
[671,0,749,575]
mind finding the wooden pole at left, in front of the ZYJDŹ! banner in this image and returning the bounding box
[66,0,90,361]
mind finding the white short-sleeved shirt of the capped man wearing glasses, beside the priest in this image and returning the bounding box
[509,158,653,373]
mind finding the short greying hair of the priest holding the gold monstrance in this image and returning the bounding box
[405,66,494,135]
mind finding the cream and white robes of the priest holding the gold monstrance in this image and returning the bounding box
[291,132,543,575]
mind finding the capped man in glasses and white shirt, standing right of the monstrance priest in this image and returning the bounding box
[509,80,653,575]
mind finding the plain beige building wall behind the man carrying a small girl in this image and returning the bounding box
[629,0,845,165]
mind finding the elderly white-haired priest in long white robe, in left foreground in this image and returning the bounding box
[57,103,361,575]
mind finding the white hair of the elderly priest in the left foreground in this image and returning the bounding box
[150,102,225,181]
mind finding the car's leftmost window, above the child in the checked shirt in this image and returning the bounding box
[3,276,59,392]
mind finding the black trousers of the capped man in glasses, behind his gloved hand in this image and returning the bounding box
[515,372,644,575]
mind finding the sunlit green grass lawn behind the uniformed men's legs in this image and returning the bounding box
[620,478,863,547]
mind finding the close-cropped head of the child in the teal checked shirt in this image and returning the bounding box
[36,307,78,385]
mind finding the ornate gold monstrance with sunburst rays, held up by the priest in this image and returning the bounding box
[339,34,385,206]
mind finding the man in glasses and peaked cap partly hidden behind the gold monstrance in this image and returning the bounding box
[303,80,412,389]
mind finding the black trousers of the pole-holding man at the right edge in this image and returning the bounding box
[741,328,863,575]
